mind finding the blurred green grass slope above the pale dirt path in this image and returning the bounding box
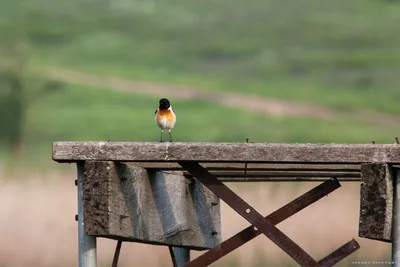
[20,0,400,114]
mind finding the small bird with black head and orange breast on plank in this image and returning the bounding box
[155,98,176,142]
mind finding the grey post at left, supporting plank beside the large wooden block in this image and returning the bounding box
[76,162,97,267]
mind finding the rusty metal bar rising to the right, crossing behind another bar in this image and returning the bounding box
[186,179,340,267]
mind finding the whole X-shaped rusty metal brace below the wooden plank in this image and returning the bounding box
[179,161,360,267]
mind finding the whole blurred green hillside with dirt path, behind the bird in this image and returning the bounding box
[0,0,400,266]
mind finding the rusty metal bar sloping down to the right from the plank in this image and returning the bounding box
[179,161,319,267]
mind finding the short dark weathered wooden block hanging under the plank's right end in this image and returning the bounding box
[359,163,393,242]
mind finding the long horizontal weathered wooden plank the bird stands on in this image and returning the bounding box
[53,142,400,164]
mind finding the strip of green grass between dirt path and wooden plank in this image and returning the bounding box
[14,80,398,169]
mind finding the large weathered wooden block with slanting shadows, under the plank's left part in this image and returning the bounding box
[83,161,221,250]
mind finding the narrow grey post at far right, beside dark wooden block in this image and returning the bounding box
[392,169,400,267]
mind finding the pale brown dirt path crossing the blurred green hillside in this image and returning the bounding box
[40,69,400,126]
